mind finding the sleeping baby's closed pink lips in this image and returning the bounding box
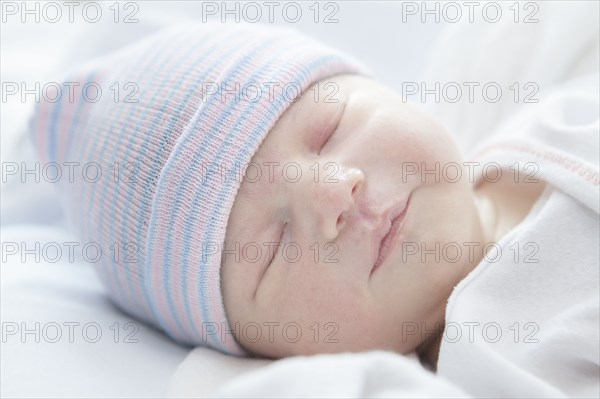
[371,195,410,274]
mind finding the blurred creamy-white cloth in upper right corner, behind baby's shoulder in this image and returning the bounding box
[422,1,600,152]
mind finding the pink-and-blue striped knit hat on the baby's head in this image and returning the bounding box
[31,24,368,356]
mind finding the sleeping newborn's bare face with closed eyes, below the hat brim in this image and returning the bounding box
[221,75,483,358]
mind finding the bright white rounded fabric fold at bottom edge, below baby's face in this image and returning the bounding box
[215,351,470,398]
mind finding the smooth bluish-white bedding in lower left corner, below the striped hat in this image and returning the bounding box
[0,223,188,398]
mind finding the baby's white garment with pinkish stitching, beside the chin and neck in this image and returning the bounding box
[438,76,600,397]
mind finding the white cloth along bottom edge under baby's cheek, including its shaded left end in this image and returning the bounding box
[168,348,469,398]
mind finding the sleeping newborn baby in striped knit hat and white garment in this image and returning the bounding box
[31,24,598,394]
